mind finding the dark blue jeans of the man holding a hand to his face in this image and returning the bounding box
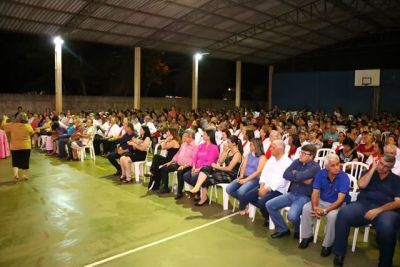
[332,201,400,267]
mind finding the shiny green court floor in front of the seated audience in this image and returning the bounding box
[0,151,400,267]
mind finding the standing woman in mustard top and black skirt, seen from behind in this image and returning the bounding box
[1,112,34,182]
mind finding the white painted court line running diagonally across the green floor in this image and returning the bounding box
[84,212,239,267]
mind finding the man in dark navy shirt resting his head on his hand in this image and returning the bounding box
[332,154,400,267]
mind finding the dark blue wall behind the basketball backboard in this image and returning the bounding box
[272,70,400,114]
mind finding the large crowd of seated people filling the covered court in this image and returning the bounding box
[9,105,400,266]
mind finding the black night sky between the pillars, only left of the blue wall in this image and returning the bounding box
[0,32,267,100]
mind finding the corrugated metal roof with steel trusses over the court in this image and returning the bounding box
[0,0,400,64]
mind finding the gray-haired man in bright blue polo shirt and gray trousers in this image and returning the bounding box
[299,154,350,257]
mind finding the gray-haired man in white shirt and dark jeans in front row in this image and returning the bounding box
[244,140,292,227]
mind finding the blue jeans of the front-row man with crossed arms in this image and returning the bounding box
[265,192,310,232]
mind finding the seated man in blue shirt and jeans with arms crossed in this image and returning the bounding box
[265,144,321,239]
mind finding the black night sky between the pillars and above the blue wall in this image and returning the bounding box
[0,31,400,100]
